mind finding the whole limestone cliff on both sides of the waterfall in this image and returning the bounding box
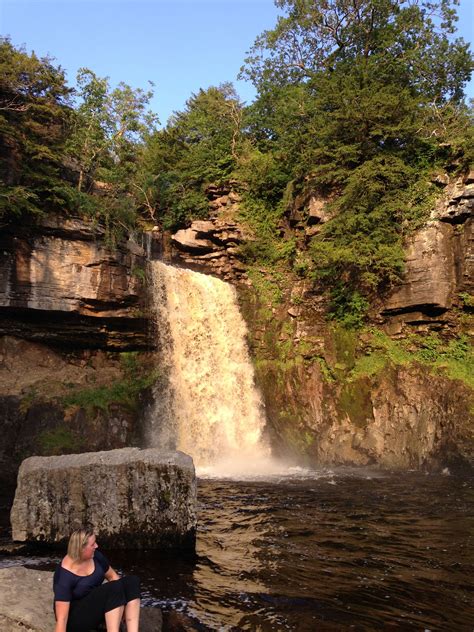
[0,174,474,482]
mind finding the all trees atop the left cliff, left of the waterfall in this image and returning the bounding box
[0,39,160,245]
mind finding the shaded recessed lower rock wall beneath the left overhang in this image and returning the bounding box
[0,336,154,488]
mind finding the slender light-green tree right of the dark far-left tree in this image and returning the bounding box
[67,68,157,243]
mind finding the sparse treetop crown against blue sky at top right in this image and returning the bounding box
[242,0,470,101]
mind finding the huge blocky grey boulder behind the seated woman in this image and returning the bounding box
[11,448,196,549]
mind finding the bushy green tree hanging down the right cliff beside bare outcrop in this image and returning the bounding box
[310,156,432,304]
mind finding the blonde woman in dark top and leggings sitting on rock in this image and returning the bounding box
[53,529,140,632]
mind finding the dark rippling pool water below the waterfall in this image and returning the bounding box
[0,471,474,632]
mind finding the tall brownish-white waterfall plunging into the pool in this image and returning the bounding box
[148,261,270,473]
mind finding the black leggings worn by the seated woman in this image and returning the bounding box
[67,575,140,632]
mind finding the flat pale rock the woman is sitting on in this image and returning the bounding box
[0,566,162,632]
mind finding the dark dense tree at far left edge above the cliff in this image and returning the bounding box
[0,39,73,219]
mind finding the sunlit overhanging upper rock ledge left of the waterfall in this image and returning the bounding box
[0,218,147,349]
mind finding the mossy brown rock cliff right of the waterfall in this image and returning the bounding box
[165,174,474,469]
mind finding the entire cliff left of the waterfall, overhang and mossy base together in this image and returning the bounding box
[0,216,154,488]
